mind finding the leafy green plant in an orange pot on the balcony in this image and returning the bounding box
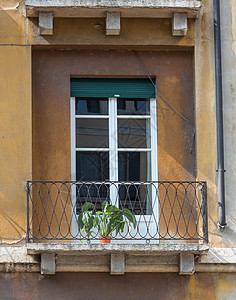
[78,201,136,244]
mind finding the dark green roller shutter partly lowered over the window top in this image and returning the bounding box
[70,78,155,98]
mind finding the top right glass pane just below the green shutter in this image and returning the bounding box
[117,98,150,115]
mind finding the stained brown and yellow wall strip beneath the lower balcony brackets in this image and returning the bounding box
[0,273,236,300]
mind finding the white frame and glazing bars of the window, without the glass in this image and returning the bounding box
[70,97,159,243]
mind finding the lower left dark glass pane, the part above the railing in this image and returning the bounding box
[76,151,109,181]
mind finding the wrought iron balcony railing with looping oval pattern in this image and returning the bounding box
[27,181,208,243]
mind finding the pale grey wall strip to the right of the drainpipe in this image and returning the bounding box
[221,0,236,247]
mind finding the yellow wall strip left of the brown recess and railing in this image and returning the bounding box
[0,0,32,242]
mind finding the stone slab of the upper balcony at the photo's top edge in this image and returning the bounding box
[25,0,201,18]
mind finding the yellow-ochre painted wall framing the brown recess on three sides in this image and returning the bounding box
[0,0,236,247]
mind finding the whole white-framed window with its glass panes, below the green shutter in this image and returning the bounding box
[71,79,158,241]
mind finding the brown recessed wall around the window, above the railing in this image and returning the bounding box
[33,49,196,240]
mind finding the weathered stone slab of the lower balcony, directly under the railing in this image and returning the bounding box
[27,243,209,255]
